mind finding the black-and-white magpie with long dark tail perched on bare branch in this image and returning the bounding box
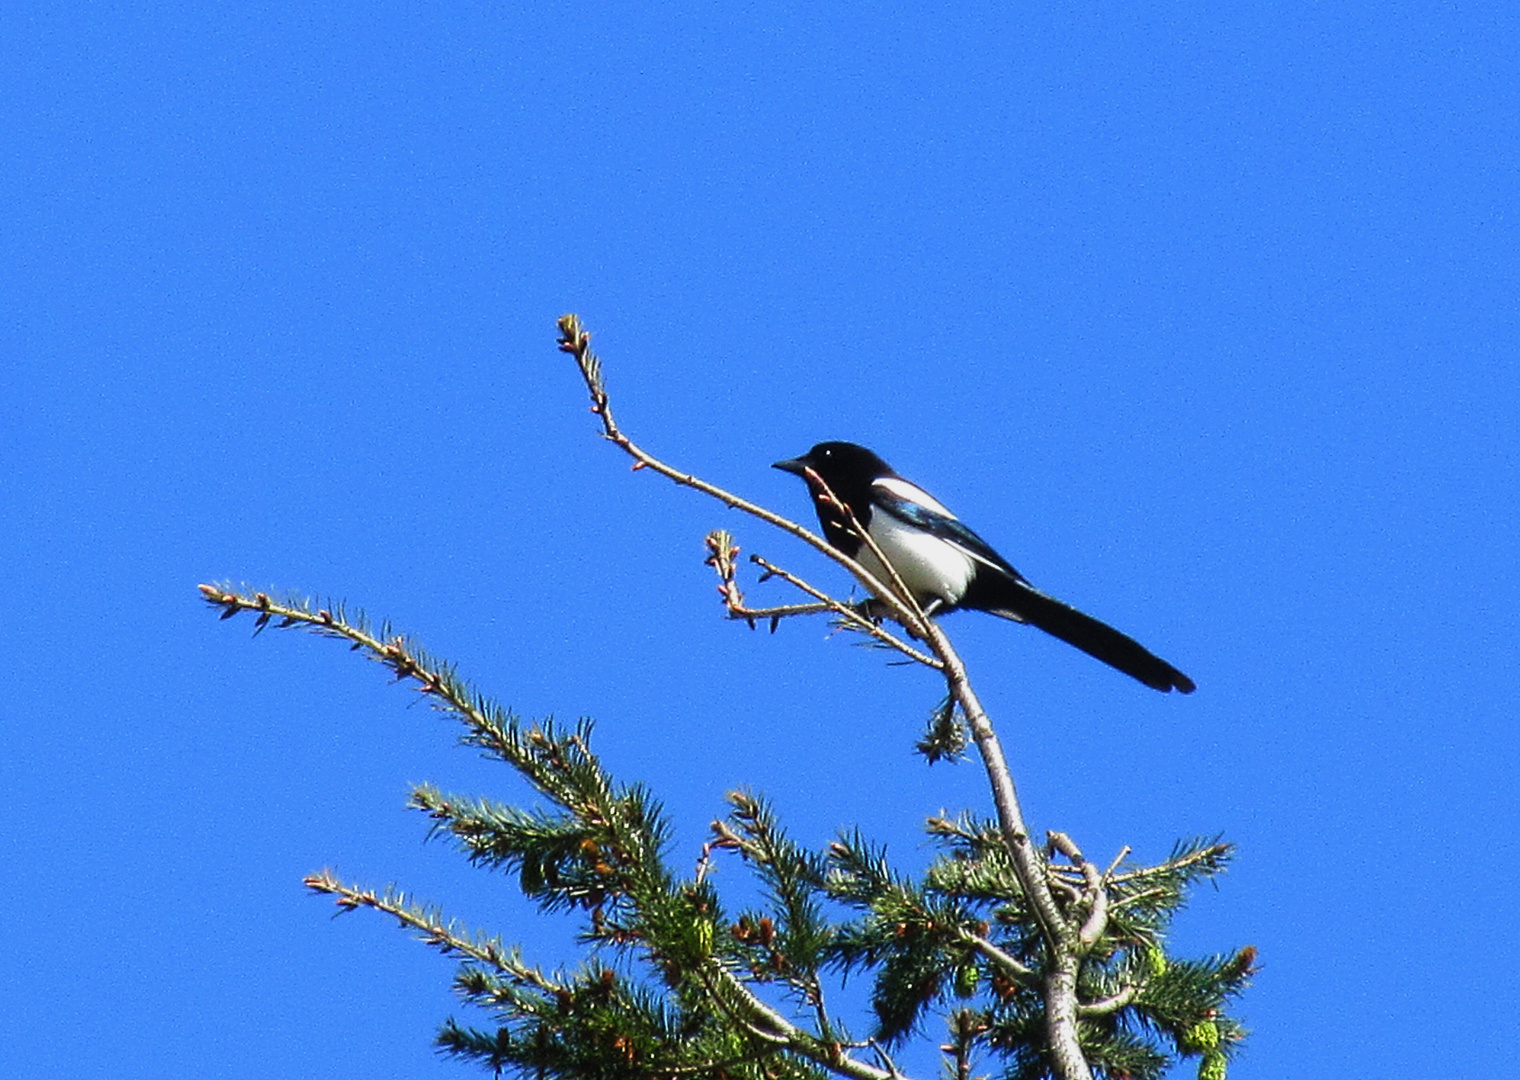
[772,442,1196,694]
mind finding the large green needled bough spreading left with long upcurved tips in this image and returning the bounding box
[201,585,912,1080]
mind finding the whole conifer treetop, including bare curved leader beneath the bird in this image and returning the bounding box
[201,316,1256,1080]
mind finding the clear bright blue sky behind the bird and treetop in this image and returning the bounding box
[0,0,1520,1078]
